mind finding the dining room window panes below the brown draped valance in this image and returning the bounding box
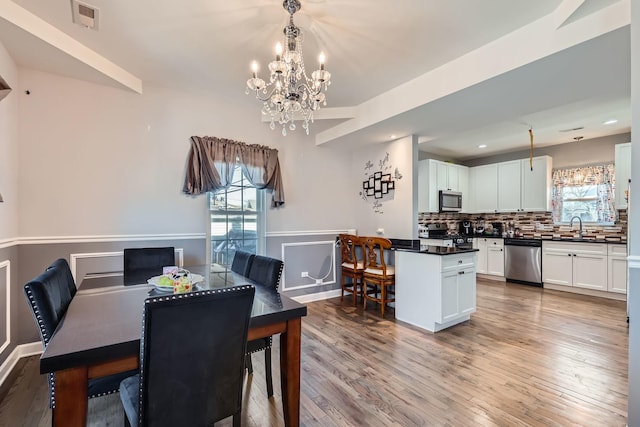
[207,163,266,268]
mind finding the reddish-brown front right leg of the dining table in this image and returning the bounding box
[280,318,302,427]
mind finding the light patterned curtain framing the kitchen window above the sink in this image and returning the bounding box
[551,164,617,223]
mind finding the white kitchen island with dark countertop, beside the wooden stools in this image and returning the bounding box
[395,246,478,332]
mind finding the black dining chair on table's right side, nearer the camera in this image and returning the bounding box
[245,255,284,397]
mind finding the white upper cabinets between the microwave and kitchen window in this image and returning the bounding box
[470,156,552,213]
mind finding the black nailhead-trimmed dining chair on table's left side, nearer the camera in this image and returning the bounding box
[24,260,134,408]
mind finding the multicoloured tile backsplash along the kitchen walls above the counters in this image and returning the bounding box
[418,210,627,243]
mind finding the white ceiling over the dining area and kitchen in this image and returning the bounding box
[0,0,630,160]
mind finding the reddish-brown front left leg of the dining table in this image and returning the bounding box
[52,366,88,427]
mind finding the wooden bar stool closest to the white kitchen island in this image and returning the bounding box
[362,237,396,317]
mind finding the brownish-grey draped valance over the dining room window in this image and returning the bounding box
[182,136,284,207]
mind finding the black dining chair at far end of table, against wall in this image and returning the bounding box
[123,246,176,286]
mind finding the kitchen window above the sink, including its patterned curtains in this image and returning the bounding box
[552,164,617,225]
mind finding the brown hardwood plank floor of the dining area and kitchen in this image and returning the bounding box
[0,279,628,426]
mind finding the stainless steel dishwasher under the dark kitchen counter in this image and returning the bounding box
[504,239,542,287]
